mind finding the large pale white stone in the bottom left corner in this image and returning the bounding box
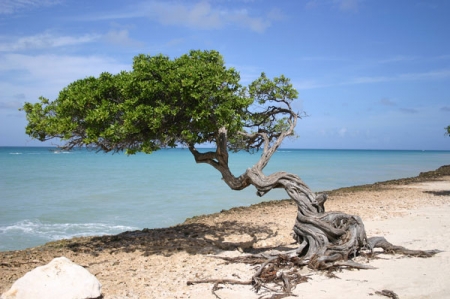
[1,257,102,299]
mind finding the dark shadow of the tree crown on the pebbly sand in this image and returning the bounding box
[53,221,277,256]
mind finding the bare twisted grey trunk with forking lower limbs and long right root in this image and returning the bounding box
[189,123,439,269]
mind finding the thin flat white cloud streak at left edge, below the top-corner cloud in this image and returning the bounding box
[0,32,99,52]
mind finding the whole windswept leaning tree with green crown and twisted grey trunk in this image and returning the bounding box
[23,51,437,296]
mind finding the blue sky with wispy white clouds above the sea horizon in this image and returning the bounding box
[0,0,450,150]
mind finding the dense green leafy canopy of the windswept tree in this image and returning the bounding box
[22,51,297,154]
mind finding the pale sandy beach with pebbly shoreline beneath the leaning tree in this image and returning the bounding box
[0,171,450,299]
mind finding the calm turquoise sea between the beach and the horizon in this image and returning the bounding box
[0,147,450,251]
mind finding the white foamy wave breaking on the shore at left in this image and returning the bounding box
[0,220,138,241]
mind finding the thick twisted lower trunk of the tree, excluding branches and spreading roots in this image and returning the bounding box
[246,168,367,268]
